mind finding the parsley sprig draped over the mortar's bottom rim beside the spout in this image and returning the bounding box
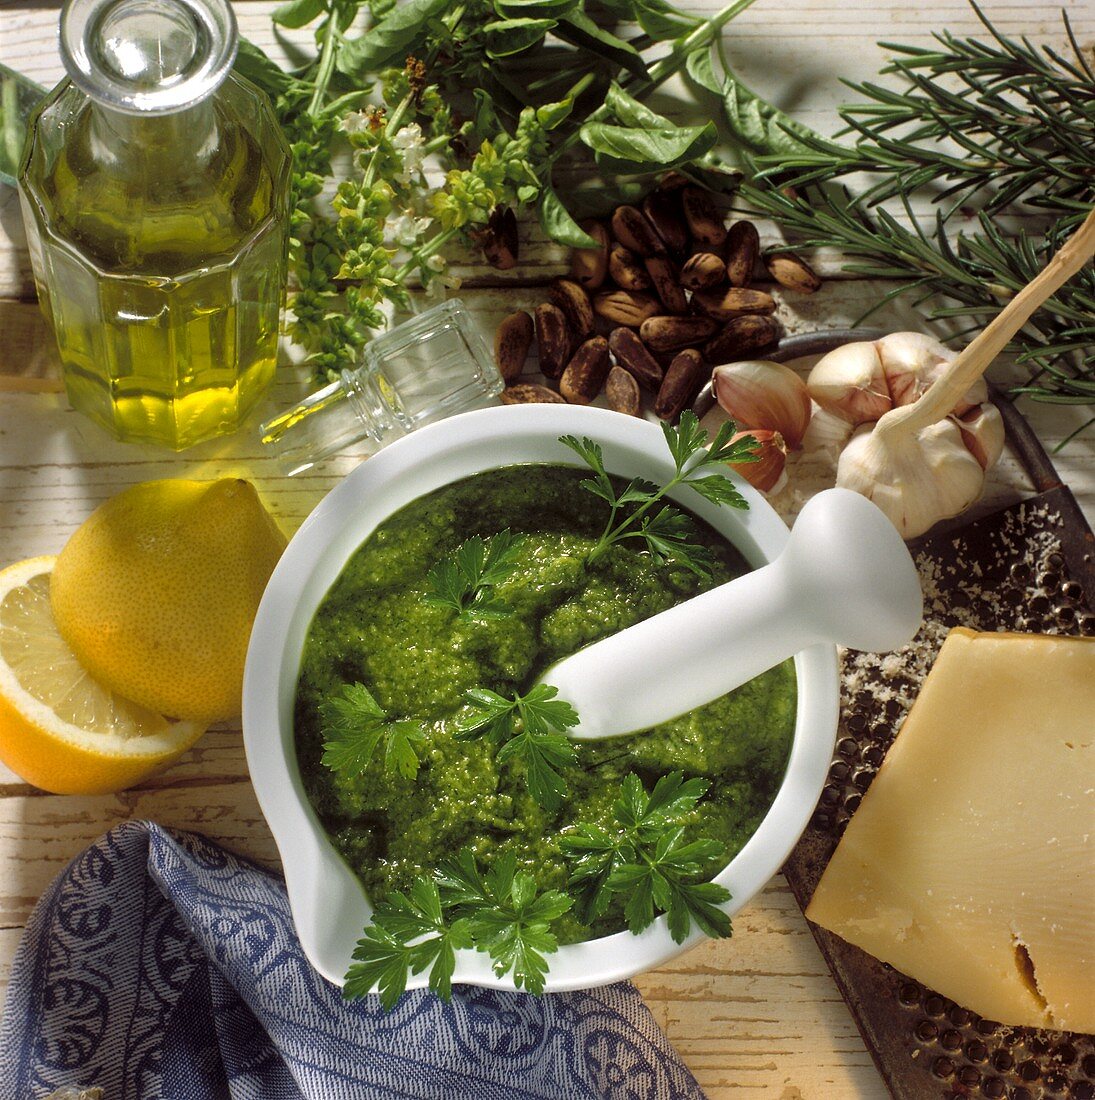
[343,848,573,1009]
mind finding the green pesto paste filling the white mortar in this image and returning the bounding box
[295,465,796,942]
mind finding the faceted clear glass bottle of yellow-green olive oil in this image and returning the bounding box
[21,0,289,450]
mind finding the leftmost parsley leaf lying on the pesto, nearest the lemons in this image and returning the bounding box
[319,683,426,779]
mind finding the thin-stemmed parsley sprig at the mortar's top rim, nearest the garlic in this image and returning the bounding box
[559,410,757,576]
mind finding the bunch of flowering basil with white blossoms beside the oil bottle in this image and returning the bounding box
[237,0,753,376]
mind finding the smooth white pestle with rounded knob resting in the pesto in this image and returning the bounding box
[540,488,923,739]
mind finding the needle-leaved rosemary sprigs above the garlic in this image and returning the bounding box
[689,4,1095,429]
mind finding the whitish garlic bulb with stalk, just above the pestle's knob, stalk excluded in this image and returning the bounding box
[836,410,985,539]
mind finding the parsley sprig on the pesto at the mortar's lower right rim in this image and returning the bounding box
[561,771,731,943]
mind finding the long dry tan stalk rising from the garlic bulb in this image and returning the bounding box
[878,210,1095,433]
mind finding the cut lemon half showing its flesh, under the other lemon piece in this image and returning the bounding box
[0,558,205,794]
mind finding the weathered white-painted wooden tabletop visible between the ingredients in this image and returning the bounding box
[0,0,1095,1100]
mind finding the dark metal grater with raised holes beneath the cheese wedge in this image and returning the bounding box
[785,488,1095,1100]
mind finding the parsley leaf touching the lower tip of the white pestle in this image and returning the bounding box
[453,684,578,810]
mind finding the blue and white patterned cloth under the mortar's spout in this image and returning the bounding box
[0,822,702,1100]
